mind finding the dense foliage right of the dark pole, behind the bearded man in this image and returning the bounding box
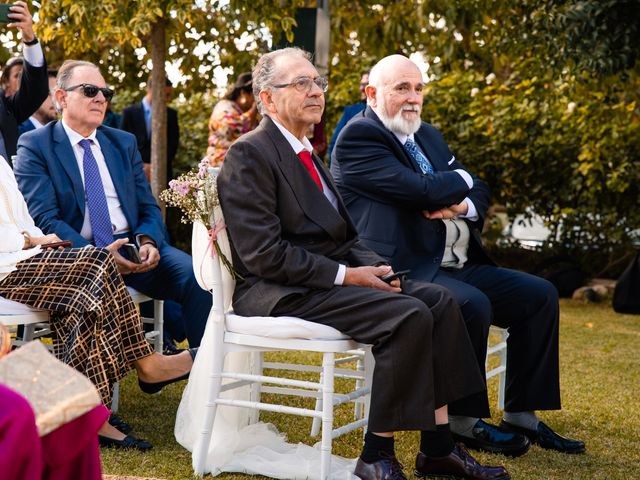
[324,0,640,272]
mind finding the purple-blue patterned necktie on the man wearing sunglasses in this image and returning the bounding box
[80,138,113,247]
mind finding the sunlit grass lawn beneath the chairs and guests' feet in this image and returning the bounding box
[102,301,640,480]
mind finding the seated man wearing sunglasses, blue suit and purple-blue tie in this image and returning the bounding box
[15,60,211,356]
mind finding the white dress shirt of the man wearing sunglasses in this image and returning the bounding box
[62,120,130,241]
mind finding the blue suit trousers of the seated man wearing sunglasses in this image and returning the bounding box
[124,244,211,347]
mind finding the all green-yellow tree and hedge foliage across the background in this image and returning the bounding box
[0,0,640,273]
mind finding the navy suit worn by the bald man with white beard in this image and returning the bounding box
[331,107,560,417]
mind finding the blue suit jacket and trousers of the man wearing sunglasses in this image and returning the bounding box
[14,122,211,346]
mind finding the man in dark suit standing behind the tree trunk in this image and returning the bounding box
[120,75,180,181]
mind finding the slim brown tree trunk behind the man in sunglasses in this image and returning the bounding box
[151,19,167,218]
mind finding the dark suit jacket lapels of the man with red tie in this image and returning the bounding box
[262,116,347,242]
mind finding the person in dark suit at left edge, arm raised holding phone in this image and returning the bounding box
[0,1,49,164]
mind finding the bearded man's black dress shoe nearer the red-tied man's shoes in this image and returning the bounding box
[451,419,531,457]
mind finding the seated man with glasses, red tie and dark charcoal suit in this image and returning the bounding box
[218,48,510,480]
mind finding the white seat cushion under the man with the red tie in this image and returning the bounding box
[226,313,349,340]
